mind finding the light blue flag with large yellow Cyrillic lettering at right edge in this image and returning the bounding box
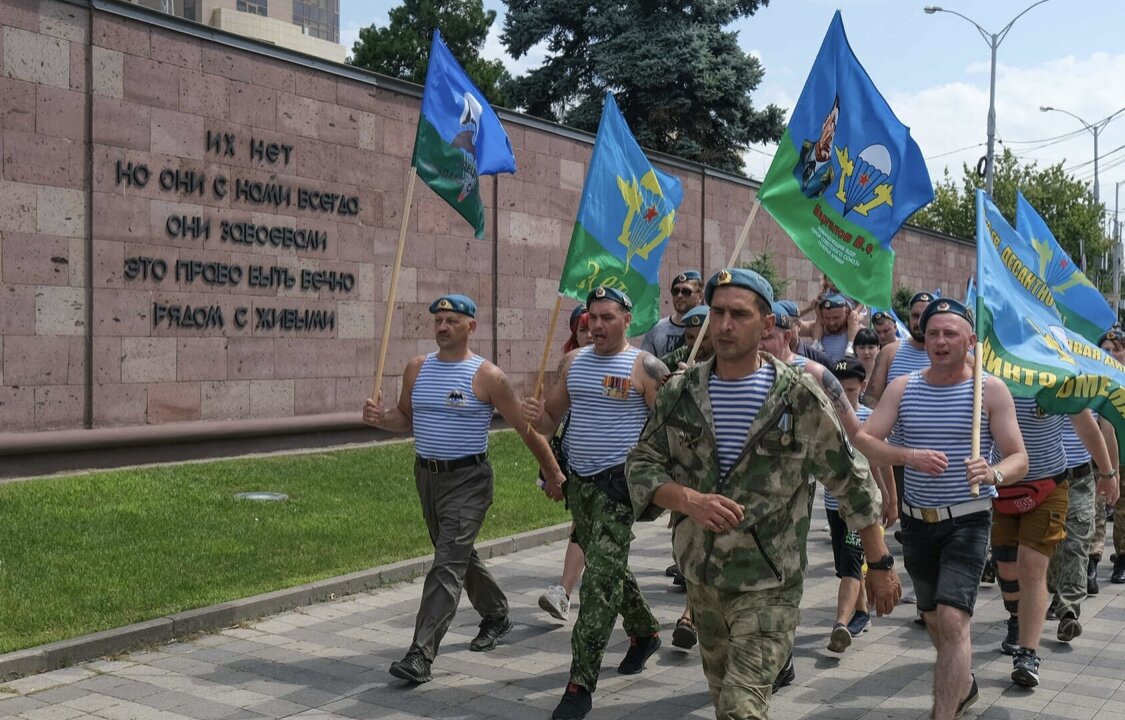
[977,190,1125,461]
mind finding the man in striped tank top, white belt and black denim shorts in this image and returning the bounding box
[856,298,1027,720]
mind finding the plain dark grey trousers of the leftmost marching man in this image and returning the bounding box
[411,461,507,662]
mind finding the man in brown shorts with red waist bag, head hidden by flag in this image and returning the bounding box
[992,397,1117,687]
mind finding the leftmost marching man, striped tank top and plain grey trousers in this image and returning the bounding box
[363,295,564,683]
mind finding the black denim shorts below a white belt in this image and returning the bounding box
[901,510,992,617]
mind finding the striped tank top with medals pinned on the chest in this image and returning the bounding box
[563,345,648,476]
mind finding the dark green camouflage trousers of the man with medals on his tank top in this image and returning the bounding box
[566,476,660,692]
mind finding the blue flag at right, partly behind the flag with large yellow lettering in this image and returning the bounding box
[1016,192,1117,342]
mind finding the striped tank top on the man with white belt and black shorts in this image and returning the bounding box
[898,370,999,507]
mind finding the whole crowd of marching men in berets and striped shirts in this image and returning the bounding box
[363,268,1125,720]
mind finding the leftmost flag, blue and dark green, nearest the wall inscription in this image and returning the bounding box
[411,30,515,240]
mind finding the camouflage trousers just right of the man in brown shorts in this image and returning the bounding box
[1047,473,1094,618]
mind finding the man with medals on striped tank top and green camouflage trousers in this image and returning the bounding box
[523,287,668,720]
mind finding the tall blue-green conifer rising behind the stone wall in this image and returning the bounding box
[501,0,785,172]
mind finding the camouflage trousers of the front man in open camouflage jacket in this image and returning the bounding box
[687,582,803,720]
